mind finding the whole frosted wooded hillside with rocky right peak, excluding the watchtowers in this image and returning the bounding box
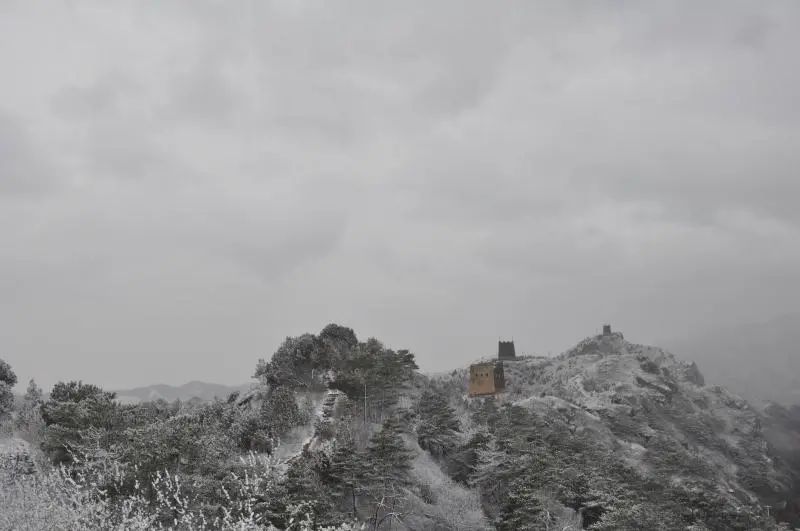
[0,325,800,531]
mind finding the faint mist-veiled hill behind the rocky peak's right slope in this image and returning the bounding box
[662,314,800,405]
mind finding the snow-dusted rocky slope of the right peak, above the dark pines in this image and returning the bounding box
[439,333,799,529]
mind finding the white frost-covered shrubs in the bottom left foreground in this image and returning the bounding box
[0,448,356,531]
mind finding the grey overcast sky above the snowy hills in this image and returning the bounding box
[0,0,800,388]
